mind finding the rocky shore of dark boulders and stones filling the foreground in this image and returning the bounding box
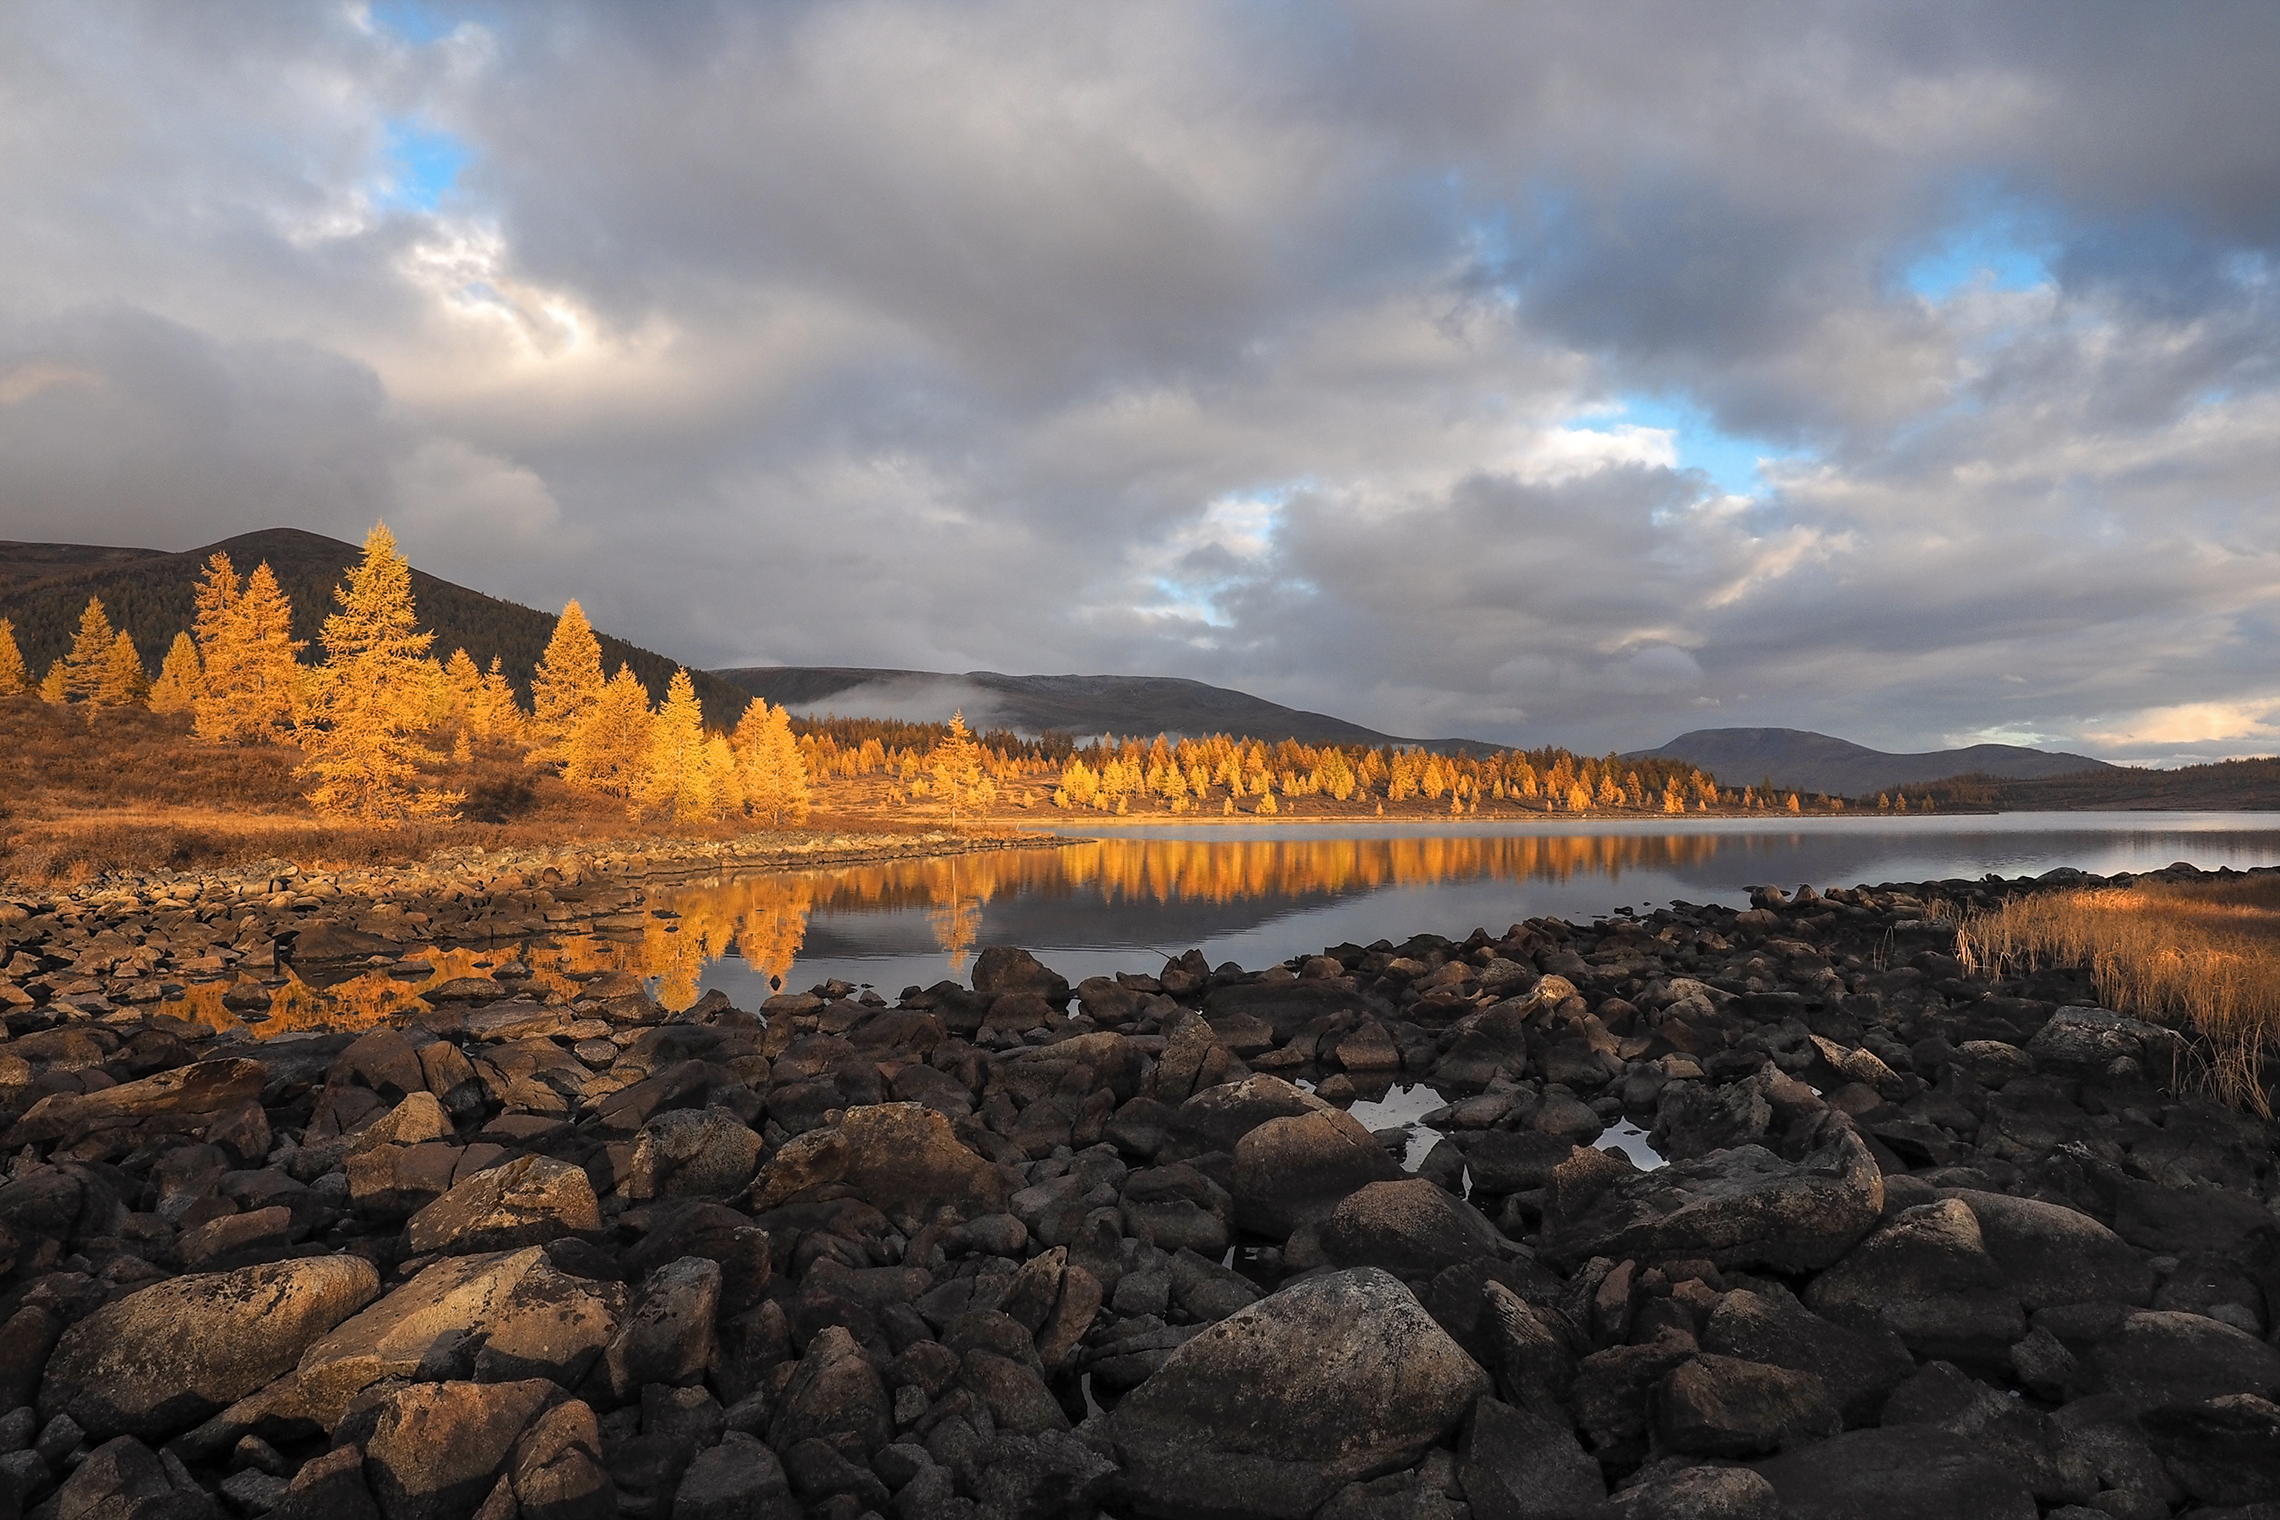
[0,859,2280,1520]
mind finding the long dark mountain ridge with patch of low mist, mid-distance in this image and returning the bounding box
[714,665,1493,750]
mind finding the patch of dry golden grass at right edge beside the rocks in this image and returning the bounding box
[1956,875,2280,1119]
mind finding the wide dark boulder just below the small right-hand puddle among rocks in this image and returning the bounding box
[1541,1130,1883,1272]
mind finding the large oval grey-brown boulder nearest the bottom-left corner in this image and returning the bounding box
[39,1256,381,1440]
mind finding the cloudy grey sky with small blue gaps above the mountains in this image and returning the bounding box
[0,0,2280,763]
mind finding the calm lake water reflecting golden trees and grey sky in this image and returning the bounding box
[675,814,2280,1007]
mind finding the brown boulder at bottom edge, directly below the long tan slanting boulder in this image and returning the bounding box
[365,1379,563,1520]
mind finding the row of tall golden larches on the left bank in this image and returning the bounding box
[0,524,809,827]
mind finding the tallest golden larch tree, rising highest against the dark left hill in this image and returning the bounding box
[296,522,465,827]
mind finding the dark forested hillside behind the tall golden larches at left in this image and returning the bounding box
[0,529,748,725]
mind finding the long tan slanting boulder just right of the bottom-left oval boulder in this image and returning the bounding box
[294,1247,616,1429]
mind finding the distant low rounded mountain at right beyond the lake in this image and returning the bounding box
[1623,729,2118,798]
